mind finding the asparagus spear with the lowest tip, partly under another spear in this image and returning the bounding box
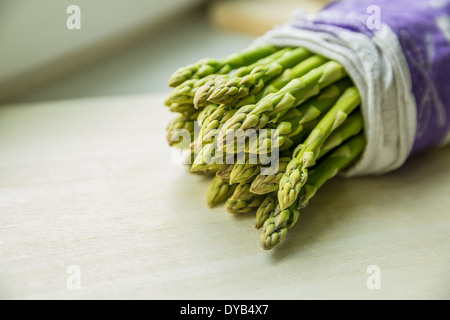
[260,133,366,250]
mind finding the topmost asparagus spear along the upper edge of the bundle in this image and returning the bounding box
[169,45,278,87]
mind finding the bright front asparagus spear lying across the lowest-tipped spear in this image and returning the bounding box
[278,87,361,209]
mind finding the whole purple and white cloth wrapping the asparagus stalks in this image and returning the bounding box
[254,0,450,176]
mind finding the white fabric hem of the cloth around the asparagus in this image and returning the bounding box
[253,10,417,176]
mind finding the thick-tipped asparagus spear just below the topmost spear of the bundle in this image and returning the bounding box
[194,48,312,105]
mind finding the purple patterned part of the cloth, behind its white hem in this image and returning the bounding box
[292,0,450,153]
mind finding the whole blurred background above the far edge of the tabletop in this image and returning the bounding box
[0,0,328,104]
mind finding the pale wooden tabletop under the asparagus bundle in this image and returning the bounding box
[0,95,450,299]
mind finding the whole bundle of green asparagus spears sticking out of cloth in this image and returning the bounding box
[166,45,366,250]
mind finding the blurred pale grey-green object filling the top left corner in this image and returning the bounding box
[0,0,205,101]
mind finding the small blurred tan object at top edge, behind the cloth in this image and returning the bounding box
[210,0,330,36]
